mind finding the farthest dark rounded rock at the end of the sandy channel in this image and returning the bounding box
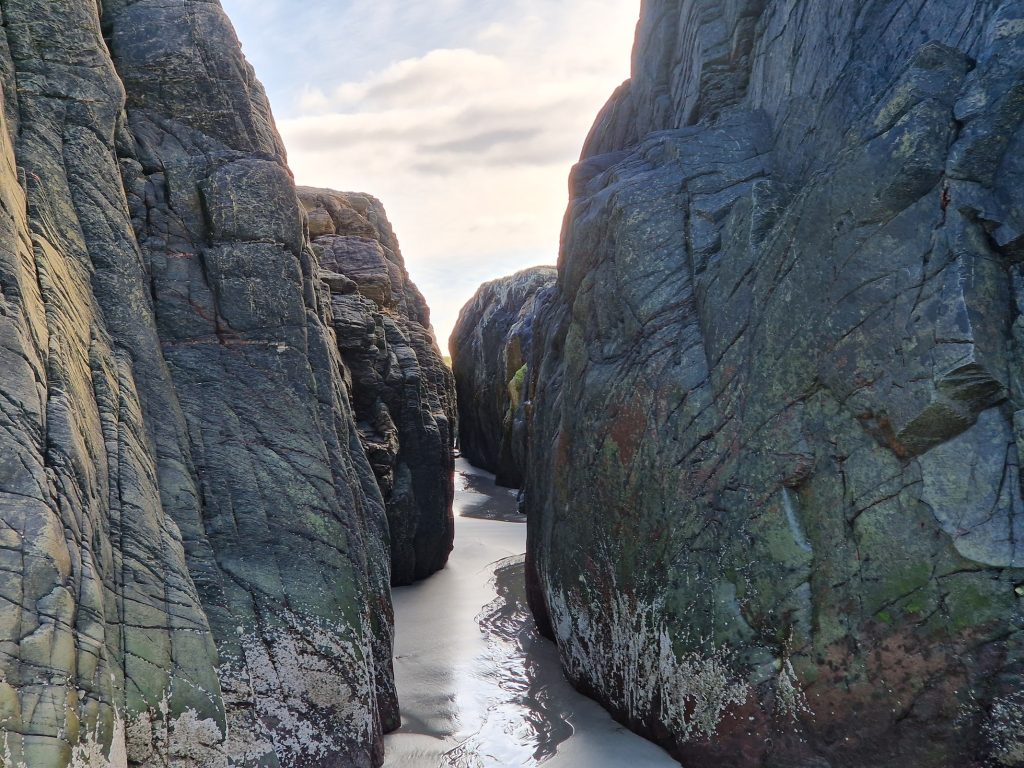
[449,266,556,487]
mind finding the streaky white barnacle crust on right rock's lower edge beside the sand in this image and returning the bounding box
[550,584,751,741]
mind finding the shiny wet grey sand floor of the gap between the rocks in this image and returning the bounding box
[385,460,679,768]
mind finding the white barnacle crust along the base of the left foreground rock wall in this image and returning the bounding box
[83,611,377,768]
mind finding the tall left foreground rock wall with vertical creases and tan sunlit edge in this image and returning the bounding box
[0,0,423,768]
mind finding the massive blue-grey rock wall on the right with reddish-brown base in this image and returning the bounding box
[526,0,1024,768]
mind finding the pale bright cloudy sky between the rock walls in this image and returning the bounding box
[222,0,640,348]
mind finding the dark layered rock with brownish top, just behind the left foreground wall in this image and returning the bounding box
[299,187,458,585]
